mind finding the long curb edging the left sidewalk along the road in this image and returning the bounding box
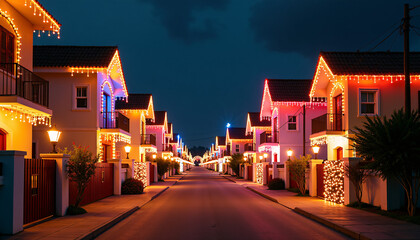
[77,178,182,240]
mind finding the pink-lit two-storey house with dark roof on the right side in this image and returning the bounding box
[258,79,327,163]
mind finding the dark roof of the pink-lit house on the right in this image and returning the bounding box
[267,79,312,102]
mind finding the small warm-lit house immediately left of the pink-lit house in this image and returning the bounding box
[244,112,271,163]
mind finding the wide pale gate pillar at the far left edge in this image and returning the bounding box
[0,151,26,234]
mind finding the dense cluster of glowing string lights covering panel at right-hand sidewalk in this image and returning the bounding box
[324,160,344,204]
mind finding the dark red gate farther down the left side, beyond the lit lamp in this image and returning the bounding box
[69,163,114,205]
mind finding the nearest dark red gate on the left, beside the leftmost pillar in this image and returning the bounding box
[23,159,56,224]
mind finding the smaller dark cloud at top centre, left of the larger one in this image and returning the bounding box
[139,0,229,44]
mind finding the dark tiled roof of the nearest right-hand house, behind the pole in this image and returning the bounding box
[320,52,420,75]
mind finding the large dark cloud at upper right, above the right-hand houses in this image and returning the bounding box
[249,0,414,56]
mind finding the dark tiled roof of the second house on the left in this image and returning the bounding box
[33,46,118,68]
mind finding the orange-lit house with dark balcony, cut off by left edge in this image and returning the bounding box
[0,0,61,158]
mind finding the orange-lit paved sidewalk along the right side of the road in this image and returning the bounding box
[223,175,420,239]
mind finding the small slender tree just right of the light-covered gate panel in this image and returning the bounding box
[344,163,370,206]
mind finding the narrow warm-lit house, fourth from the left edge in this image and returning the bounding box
[146,111,168,158]
